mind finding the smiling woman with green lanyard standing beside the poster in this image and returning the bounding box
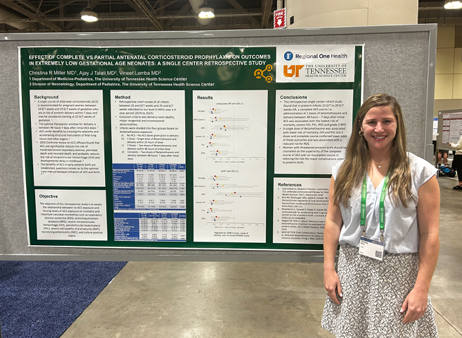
[322,94,440,338]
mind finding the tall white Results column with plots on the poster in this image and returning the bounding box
[193,90,268,243]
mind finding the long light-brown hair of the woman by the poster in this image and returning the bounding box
[334,94,415,207]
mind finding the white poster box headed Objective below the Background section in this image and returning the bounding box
[35,189,107,241]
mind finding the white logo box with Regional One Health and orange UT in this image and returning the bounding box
[276,45,355,83]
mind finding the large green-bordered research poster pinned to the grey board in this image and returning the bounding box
[18,45,364,250]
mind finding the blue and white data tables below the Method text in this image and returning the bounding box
[112,164,186,241]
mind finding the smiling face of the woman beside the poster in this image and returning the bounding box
[361,106,397,151]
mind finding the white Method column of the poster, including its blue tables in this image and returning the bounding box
[111,90,186,241]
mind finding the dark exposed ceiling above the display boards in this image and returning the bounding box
[0,0,462,33]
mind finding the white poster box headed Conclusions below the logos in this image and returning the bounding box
[274,90,353,175]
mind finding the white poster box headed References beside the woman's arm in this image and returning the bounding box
[273,178,330,244]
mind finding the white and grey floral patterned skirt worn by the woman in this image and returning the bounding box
[321,244,438,338]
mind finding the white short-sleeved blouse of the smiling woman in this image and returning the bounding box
[332,153,437,253]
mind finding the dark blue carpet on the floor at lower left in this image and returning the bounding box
[0,261,127,338]
